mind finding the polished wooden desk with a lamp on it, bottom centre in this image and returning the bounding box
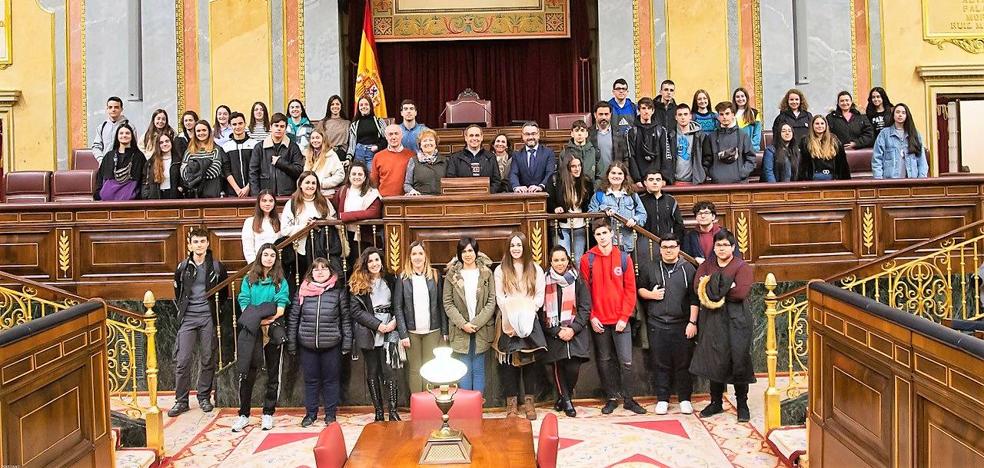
[345,418,536,468]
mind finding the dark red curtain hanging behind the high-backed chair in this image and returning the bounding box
[348,0,592,127]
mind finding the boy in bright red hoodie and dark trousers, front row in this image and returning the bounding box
[581,218,646,414]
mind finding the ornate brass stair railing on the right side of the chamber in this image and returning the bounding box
[765,221,984,430]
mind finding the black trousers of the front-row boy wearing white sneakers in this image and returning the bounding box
[649,323,694,401]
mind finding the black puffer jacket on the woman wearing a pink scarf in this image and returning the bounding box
[287,281,352,353]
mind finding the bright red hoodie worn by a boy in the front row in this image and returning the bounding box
[581,246,636,325]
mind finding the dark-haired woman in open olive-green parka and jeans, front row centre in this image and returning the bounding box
[443,237,496,392]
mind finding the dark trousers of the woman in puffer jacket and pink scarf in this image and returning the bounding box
[300,346,342,417]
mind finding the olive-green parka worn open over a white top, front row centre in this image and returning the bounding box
[443,253,498,354]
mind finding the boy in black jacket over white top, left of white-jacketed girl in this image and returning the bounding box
[249,112,304,197]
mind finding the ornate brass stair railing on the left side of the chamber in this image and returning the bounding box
[0,272,164,457]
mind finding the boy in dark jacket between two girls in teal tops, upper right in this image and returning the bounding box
[703,101,756,184]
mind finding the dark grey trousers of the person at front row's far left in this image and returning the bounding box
[174,313,219,404]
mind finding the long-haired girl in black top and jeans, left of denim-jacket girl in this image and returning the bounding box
[547,154,594,259]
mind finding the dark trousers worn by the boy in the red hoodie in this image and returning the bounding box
[591,325,632,400]
